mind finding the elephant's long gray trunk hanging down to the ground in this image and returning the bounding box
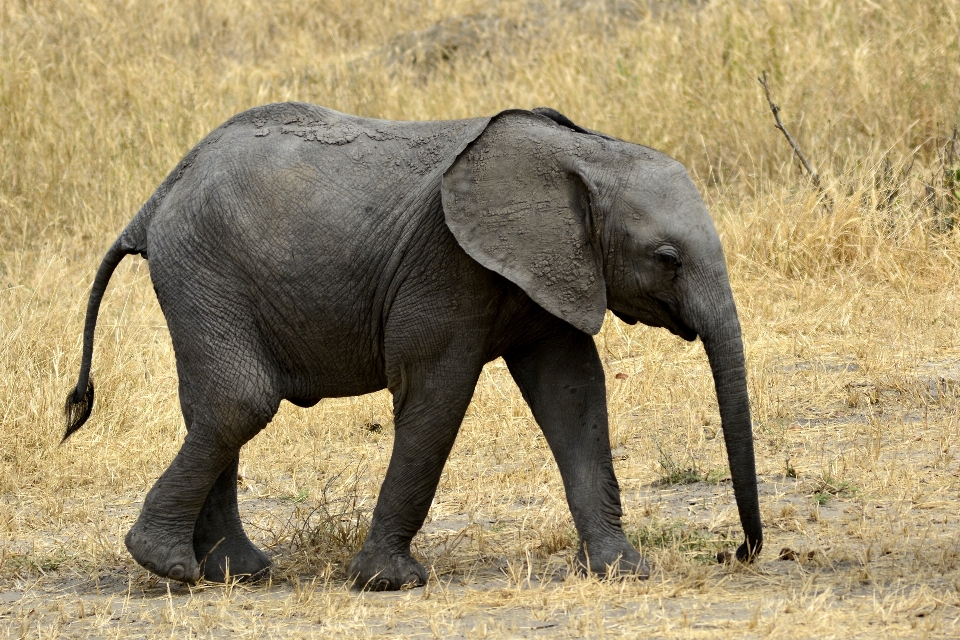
[696,273,763,561]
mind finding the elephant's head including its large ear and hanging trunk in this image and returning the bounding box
[441,110,763,560]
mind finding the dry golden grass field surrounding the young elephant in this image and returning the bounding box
[0,0,960,638]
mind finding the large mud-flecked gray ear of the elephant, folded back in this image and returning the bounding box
[441,111,607,334]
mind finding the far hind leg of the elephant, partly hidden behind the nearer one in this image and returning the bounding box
[193,455,270,582]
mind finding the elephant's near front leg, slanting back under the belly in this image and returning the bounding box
[349,366,479,591]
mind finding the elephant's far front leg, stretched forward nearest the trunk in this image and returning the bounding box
[504,327,650,578]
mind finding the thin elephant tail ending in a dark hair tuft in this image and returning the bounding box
[60,234,146,442]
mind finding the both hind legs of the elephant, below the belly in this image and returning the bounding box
[125,352,280,583]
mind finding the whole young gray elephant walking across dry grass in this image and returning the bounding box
[67,104,762,589]
